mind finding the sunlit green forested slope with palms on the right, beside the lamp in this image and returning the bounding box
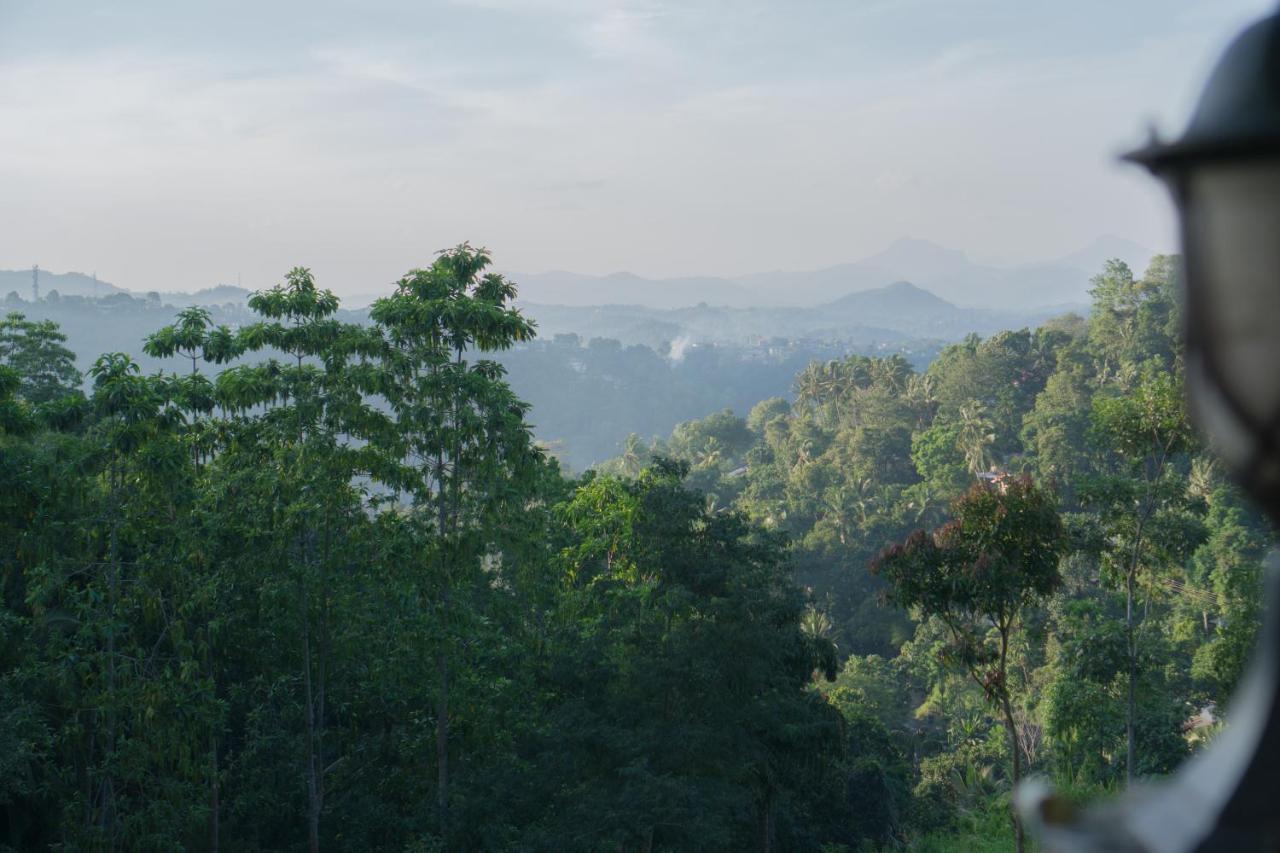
[588,251,1274,849]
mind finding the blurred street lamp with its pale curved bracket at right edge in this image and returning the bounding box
[1018,13,1280,853]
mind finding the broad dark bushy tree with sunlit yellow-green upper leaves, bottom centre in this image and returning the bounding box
[549,461,840,853]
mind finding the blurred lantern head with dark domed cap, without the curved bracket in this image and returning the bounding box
[1125,15,1280,514]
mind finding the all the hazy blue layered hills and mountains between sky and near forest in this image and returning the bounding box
[0,240,1144,470]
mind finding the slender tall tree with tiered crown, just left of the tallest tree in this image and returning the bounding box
[215,268,381,853]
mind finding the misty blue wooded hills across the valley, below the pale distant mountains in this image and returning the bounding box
[0,291,942,471]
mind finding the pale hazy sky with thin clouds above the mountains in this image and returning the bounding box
[0,0,1274,293]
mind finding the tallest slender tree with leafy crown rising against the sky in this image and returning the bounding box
[370,243,539,847]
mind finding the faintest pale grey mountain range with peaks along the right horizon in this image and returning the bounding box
[511,237,1155,310]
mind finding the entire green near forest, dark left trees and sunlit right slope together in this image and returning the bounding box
[0,245,1274,853]
